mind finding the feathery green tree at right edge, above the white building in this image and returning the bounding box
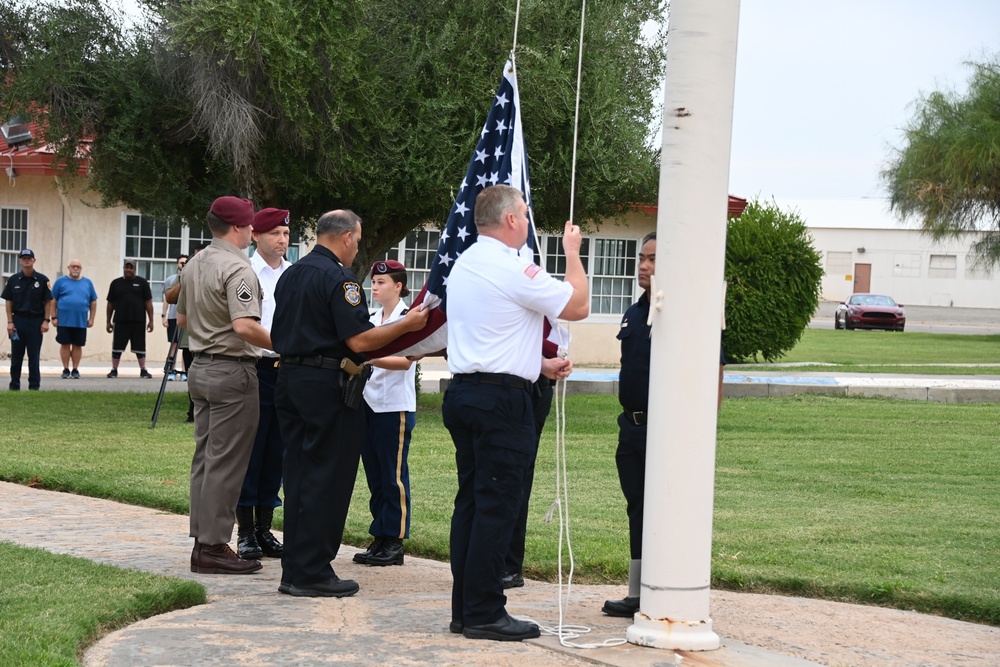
[882,59,1000,267]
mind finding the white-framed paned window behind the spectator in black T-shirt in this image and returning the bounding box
[123,213,212,301]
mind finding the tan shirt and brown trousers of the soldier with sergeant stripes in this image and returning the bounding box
[177,239,262,545]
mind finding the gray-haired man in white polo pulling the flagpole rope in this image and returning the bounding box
[442,185,590,641]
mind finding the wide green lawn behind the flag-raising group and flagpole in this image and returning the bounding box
[0,386,1000,625]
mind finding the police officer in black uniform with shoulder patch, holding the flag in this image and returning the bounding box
[271,210,428,597]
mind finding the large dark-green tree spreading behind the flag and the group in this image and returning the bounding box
[0,0,665,266]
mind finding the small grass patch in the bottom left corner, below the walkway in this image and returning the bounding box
[0,542,205,667]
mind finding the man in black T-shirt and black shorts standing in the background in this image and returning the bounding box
[107,259,154,378]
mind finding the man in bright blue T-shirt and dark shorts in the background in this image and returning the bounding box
[52,259,97,380]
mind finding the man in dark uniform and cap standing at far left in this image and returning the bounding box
[0,248,52,391]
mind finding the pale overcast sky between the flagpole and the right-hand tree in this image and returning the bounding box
[729,0,1000,198]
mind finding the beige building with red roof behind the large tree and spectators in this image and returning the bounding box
[0,124,746,372]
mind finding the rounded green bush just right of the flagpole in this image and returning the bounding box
[722,200,823,361]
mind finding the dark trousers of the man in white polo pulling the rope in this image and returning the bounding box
[442,379,536,626]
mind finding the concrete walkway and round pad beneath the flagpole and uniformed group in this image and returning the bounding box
[0,483,1000,667]
